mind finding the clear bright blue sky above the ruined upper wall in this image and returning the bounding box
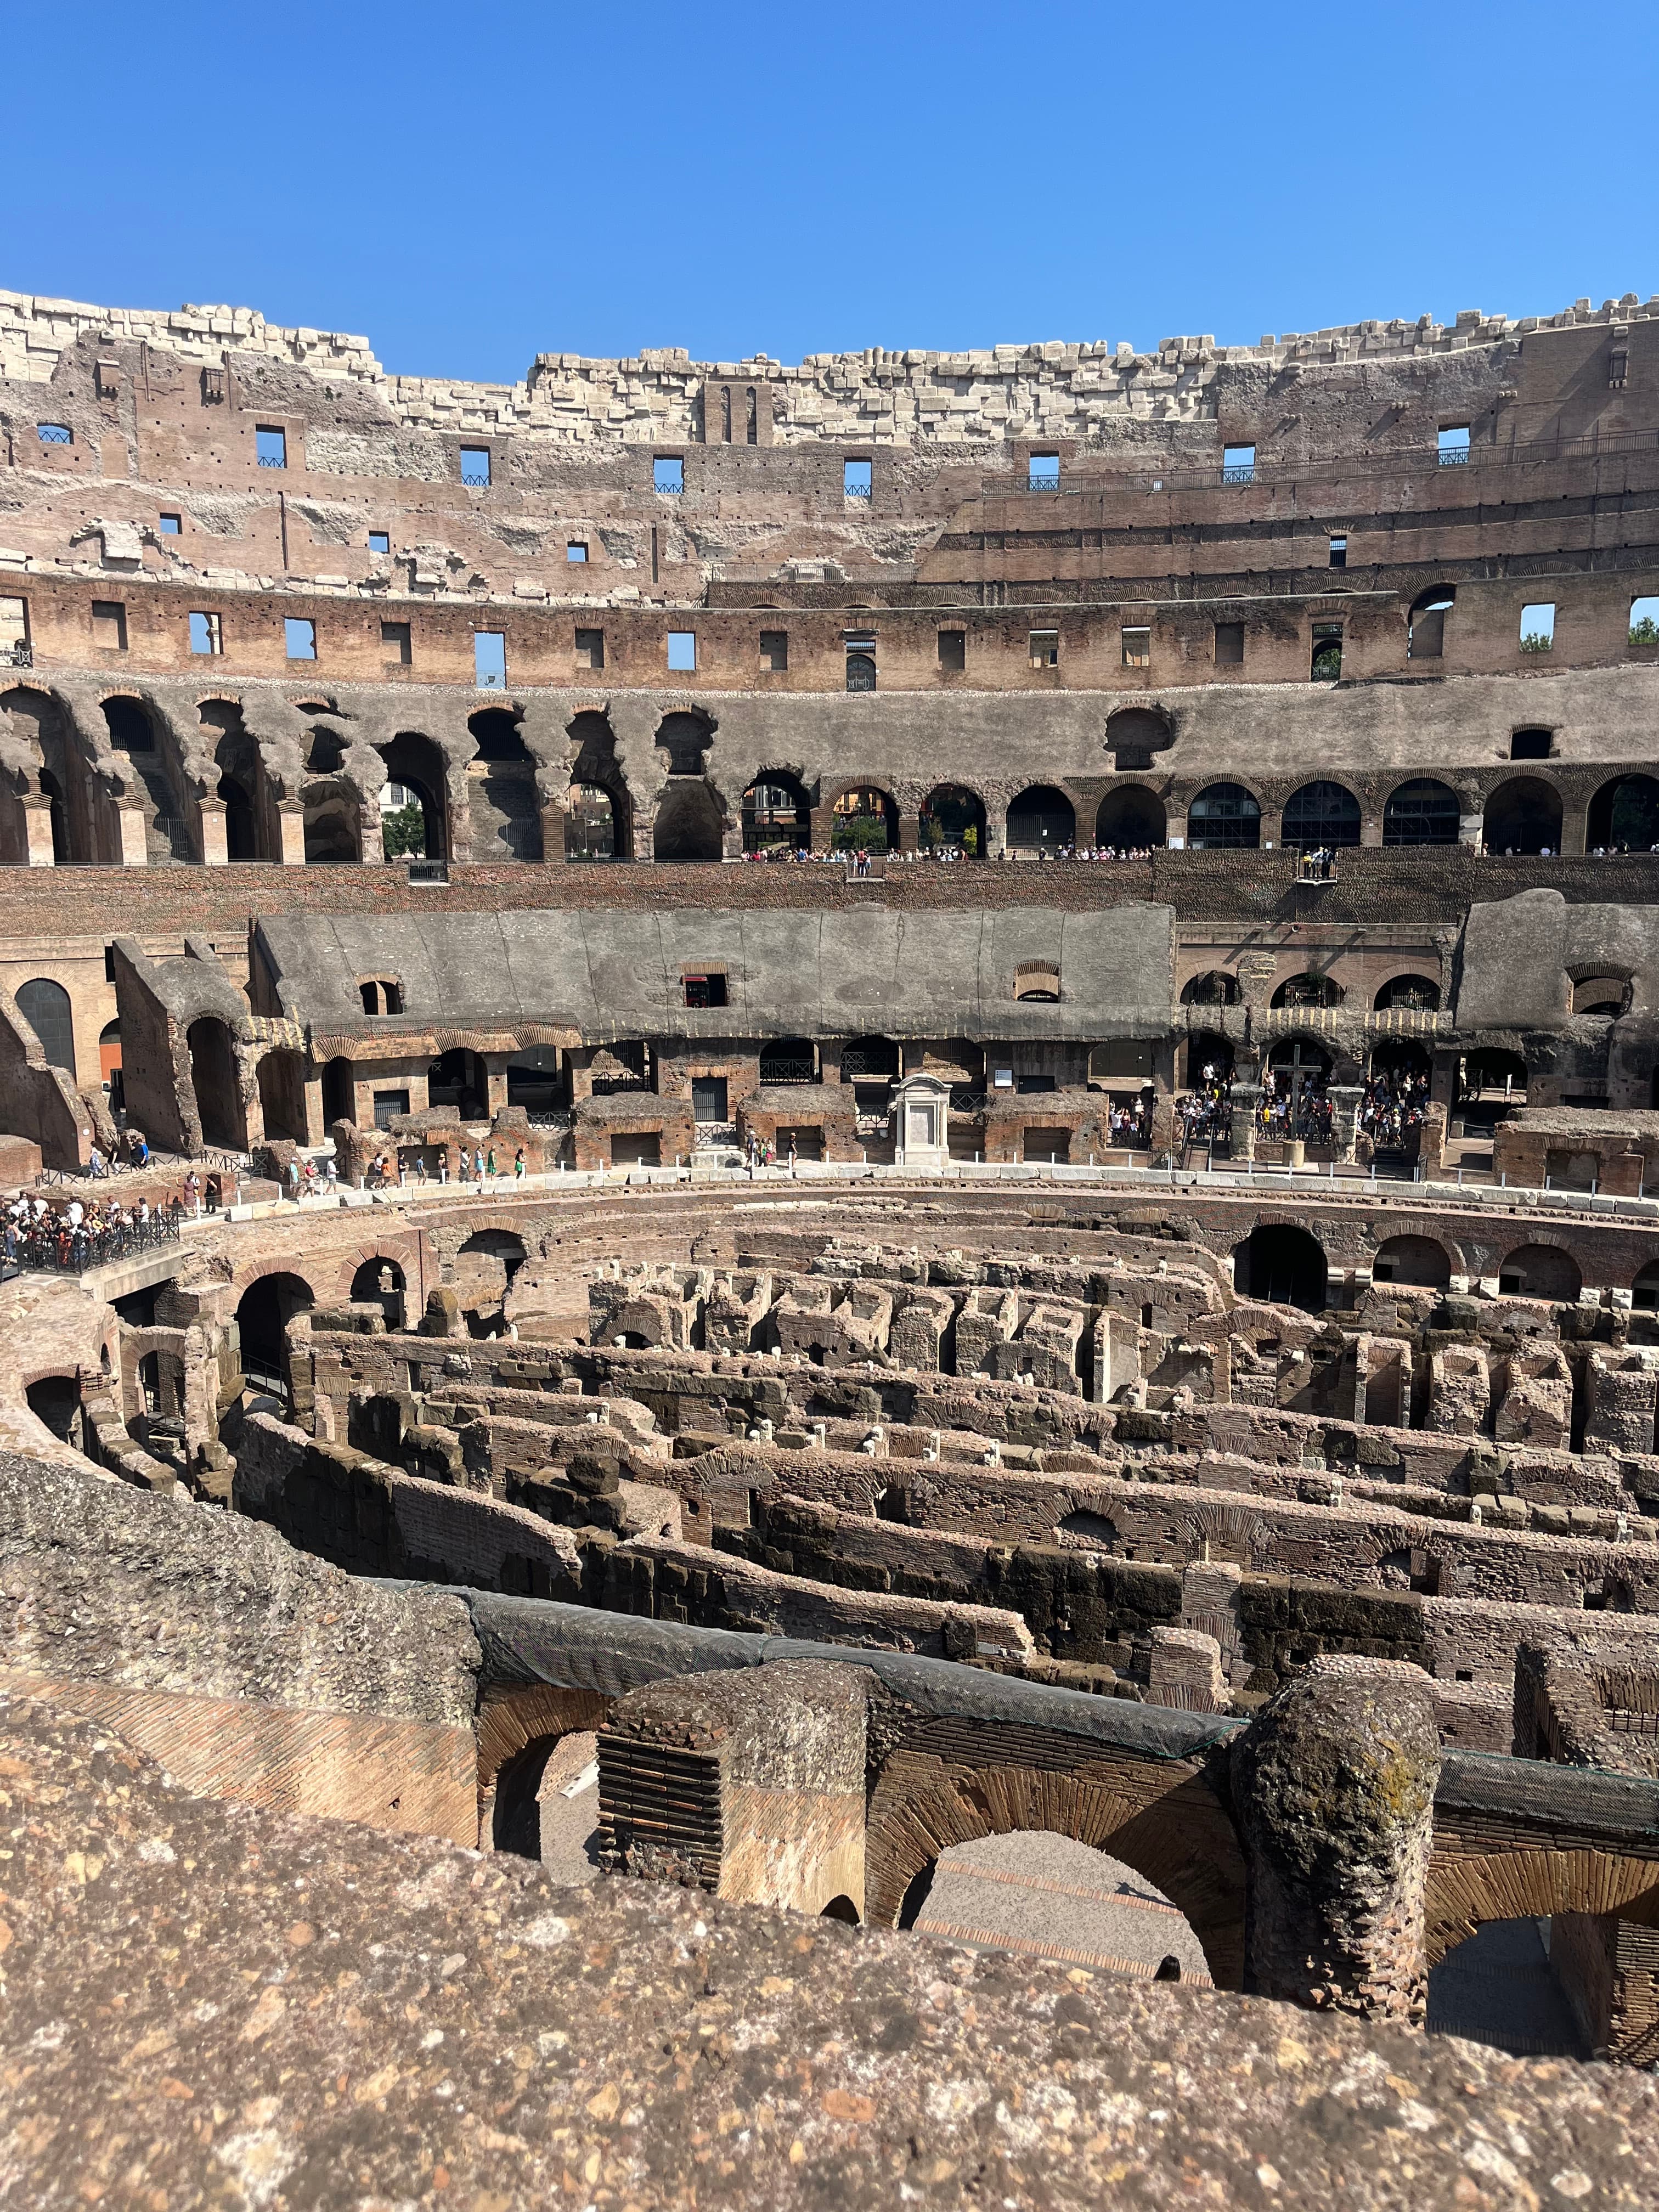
[0,0,1659,378]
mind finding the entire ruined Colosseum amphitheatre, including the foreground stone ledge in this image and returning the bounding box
[0,292,1659,2212]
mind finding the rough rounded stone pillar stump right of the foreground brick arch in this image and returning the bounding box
[1232,1657,1440,2026]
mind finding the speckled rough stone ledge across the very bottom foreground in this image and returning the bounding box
[0,1699,1659,2212]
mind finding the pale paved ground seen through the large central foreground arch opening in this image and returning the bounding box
[898,1827,1212,1989]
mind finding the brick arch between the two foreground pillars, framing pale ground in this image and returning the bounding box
[865,1723,1245,1989]
